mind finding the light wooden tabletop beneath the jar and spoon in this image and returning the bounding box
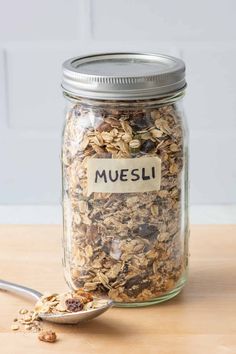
[0,225,236,354]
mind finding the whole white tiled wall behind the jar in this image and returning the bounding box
[0,0,236,205]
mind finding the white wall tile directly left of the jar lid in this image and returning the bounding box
[6,46,65,132]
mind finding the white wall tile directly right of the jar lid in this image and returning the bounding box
[182,44,236,133]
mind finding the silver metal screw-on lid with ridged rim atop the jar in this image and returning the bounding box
[62,53,186,100]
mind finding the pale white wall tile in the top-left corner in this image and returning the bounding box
[0,0,79,42]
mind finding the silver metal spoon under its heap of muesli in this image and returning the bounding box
[0,280,113,324]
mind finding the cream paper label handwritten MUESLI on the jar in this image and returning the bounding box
[87,156,161,195]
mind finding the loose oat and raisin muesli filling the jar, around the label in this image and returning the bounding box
[62,101,186,303]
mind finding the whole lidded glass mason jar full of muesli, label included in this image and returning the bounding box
[62,53,189,306]
